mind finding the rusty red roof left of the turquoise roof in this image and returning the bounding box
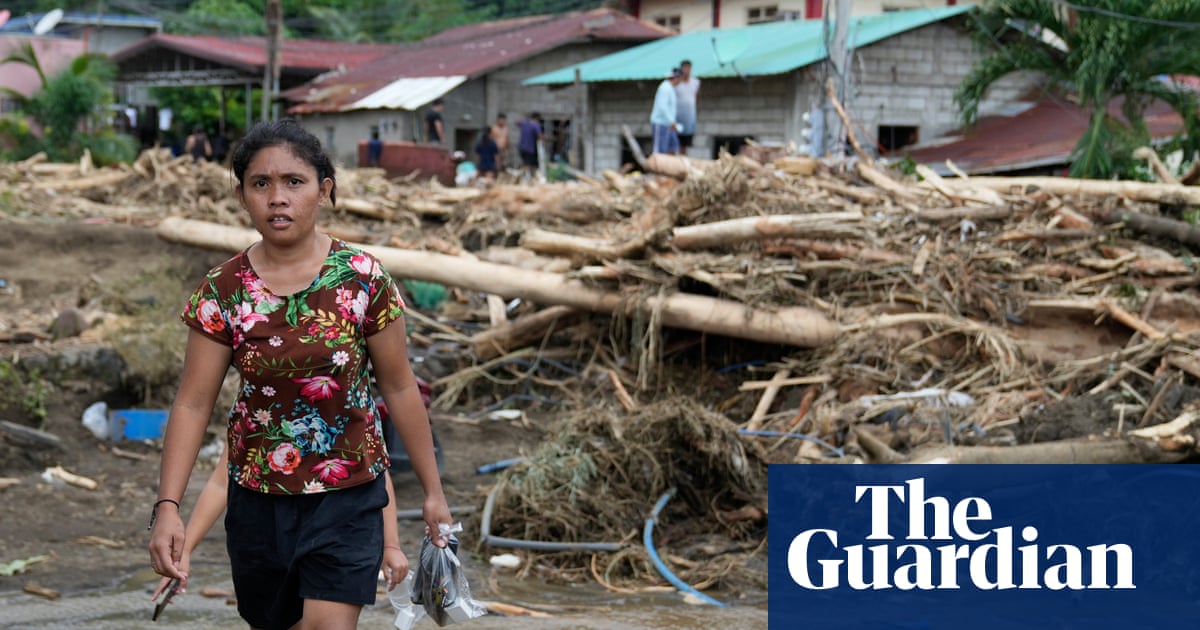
[282,8,673,114]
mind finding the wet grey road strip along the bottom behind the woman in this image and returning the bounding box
[0,565,767,630]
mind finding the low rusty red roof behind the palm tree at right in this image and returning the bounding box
[895,96,1183,175]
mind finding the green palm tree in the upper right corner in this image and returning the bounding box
[955,0,1200,179]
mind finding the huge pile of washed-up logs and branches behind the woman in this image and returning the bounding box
[0,145,1200,461]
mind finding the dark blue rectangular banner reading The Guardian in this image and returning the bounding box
[768,464,1200,630]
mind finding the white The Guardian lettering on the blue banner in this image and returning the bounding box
[787,478,1136,590]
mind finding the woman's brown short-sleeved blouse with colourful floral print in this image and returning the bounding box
[182,239,404,494]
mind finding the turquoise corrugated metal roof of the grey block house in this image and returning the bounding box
[523,5,974,85]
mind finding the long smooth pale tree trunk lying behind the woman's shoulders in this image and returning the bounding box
[158,217,839,348]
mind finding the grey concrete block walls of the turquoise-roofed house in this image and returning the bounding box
[587,23,1038,172]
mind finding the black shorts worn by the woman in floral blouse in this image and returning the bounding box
[224,475,388,630]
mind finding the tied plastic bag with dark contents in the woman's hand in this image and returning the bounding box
[408,523,487,630]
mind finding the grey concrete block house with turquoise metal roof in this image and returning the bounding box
[524,6,1040,170]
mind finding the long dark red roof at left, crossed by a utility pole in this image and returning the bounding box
[110,34,397,74]
